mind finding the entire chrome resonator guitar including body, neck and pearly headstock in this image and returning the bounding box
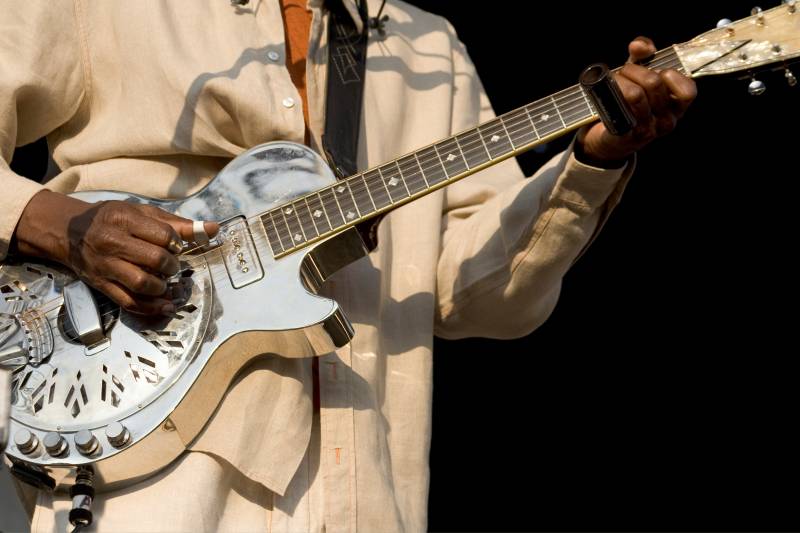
[0,0,800,488]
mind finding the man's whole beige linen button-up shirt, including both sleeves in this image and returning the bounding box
[0,0,632,531]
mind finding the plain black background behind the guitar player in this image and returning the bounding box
[9,0,800,531]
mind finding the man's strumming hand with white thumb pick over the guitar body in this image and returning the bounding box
[15,190,219,314]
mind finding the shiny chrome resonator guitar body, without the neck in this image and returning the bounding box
[0,142,366,488]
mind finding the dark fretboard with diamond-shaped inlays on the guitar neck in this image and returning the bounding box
[261,47,682,257]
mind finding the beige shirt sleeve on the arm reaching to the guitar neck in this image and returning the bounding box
[436,25,634,339]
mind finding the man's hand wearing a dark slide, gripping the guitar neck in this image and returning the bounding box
[577,37,697,167]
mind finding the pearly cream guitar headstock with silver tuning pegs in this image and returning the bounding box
[675,0,800,89]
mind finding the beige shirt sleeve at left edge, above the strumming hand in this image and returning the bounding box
[0,0,86,259]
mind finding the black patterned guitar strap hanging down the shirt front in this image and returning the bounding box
[322,0,380,250]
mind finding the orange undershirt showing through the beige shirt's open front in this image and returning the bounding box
[280,0,320,411]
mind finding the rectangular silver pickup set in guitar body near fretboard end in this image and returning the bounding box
[215,217,264,289]
